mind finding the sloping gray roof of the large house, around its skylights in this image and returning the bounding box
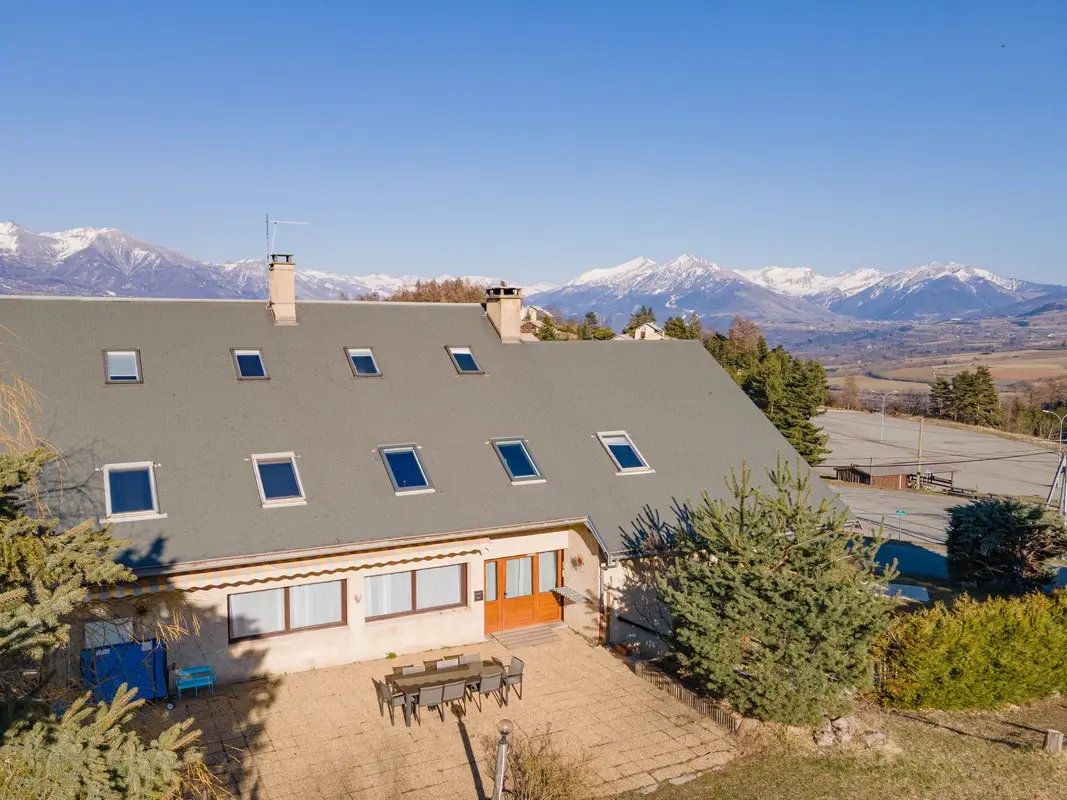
[0,298,831,570]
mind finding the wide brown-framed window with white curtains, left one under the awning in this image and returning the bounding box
[228,580,348,641]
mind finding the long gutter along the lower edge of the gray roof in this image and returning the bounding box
[133,516,597,580]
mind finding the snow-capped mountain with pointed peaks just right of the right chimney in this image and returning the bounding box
[537,254,832,327]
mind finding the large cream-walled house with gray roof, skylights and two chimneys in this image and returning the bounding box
[0,256,825,681]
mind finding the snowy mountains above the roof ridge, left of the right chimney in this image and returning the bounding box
[0,222,499,300]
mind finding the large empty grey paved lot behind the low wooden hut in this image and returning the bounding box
[816,411,1057,498]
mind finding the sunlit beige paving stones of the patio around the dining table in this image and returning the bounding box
[169,628,736,800]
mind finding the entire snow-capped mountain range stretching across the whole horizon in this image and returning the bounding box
[0,222,1067,327]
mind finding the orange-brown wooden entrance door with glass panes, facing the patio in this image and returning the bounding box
[485,550,563,634]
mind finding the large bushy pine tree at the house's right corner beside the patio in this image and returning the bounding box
[658,463,892,724]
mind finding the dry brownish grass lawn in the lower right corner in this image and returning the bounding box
[623,698,1067,800]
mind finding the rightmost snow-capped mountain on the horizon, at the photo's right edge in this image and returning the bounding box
[830,261,1063,320]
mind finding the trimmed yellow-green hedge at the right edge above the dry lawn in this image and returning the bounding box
[876,591,1067,709]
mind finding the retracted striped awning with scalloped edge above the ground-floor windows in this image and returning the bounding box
[90,542,481,601]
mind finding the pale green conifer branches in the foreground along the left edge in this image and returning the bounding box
[0,413,201,800]
